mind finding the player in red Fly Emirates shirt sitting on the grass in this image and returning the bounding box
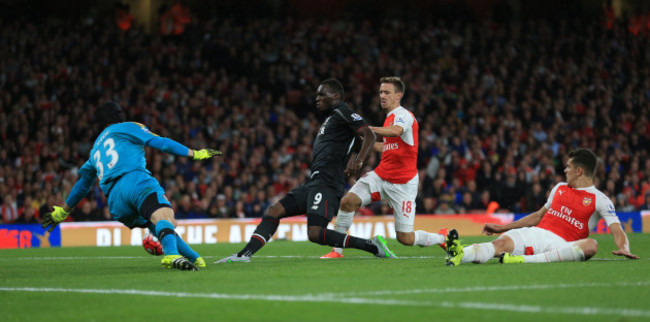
[446,149,639,266]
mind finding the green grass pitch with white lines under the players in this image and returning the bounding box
[0,234,650,322]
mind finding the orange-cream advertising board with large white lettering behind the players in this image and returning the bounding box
[60,214,513,247]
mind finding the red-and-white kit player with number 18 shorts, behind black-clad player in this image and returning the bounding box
[321,77,447,258]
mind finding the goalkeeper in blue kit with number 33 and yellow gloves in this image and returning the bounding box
[42,102,221,270]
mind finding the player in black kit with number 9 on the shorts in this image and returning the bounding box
[216,79,395,263]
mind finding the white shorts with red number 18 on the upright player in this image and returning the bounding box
[350,171,420,233]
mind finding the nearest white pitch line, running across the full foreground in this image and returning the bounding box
[0,287,650,317]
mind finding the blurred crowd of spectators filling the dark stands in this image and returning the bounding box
[0,1,650,223]
